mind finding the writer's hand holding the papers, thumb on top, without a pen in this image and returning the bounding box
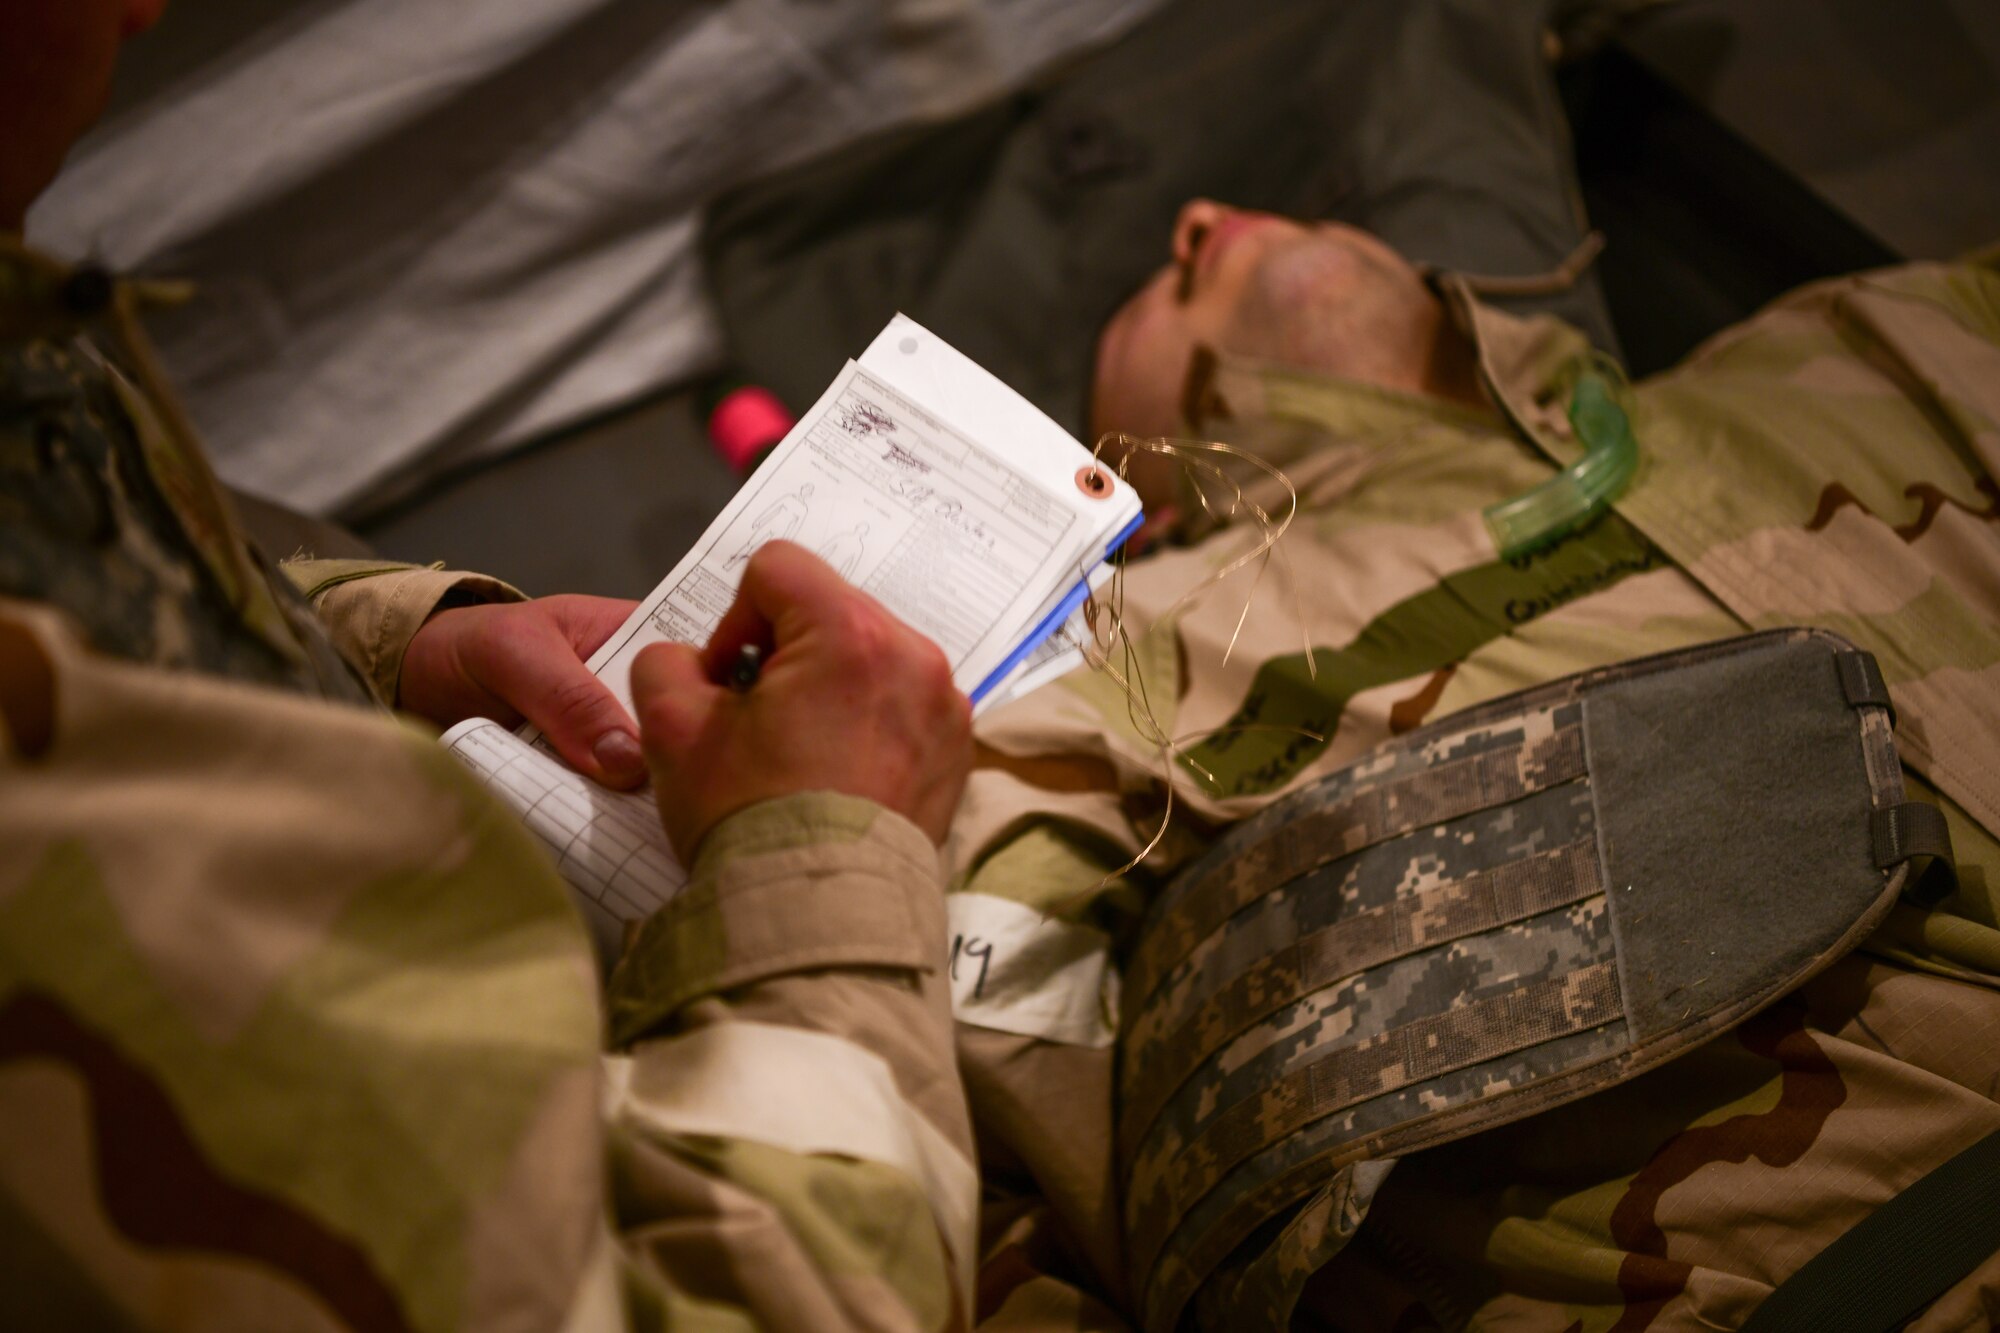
[408,596,646,787]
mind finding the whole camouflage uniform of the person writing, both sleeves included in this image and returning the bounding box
[0,240,978,1329]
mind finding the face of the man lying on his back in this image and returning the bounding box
[1090,200,1436,436]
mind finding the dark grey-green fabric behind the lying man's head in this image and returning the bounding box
[702,0,1646,434]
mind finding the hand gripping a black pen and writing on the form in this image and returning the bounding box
[632,542,972,865]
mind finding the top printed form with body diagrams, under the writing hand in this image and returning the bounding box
[590,352,1102,709]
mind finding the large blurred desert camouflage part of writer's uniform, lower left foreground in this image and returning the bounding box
[0,598,620,1333]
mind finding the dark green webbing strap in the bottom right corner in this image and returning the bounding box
[1742,1131,2000,1333]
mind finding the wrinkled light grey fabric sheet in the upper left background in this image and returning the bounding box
[28,0,1158,516]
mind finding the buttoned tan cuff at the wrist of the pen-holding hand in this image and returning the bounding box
[608,793,944,1047]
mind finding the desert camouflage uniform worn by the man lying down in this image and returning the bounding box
[946,266,2000,1333]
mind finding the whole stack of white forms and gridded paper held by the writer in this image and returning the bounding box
[444,314,1142,957]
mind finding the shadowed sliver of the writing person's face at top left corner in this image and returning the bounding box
[0,0,166,230]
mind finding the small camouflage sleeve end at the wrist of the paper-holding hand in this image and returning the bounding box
[282,560,524,703]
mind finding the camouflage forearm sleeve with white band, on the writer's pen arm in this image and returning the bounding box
[606,793,980,1331]
